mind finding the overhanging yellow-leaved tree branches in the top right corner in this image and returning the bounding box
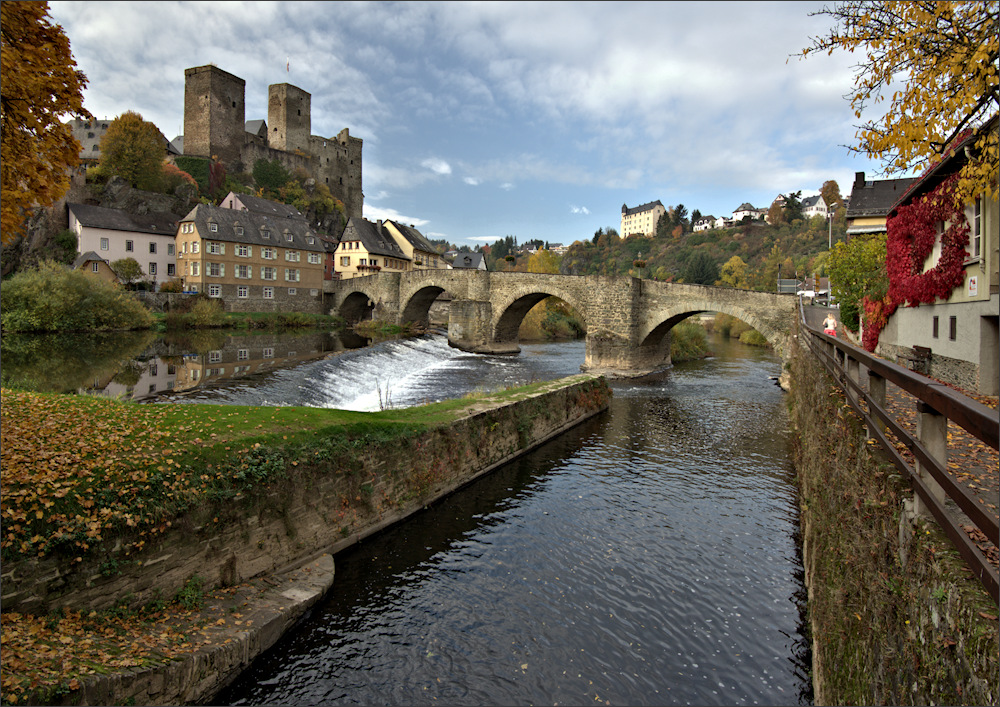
[799,0,1000,202]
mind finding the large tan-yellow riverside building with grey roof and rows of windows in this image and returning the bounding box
[176,204,325,312]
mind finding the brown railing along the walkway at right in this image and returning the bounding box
[799,304,1000,603]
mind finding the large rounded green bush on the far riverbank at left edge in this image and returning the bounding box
[0,261,153,332]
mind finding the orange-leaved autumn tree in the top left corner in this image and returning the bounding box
[0,2,91,244]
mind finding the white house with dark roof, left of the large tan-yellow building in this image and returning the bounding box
[67,204,178,288]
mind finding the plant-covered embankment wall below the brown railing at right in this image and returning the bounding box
[789,330,1000,705]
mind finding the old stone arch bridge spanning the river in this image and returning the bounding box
[324,270,798,376]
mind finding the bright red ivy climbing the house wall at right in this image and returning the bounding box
[862,175,969,351]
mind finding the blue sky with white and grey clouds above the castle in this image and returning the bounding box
[50,2,892,249]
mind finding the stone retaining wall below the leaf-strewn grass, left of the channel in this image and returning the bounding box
[0,376,610,614]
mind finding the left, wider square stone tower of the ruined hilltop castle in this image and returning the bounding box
[184,66,246,164]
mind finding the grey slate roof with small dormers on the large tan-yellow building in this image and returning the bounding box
[181,204,325,253]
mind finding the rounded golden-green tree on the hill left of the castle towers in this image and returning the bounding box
[100,111,166,191]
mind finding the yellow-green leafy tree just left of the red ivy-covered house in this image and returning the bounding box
[827,233,889,331]
